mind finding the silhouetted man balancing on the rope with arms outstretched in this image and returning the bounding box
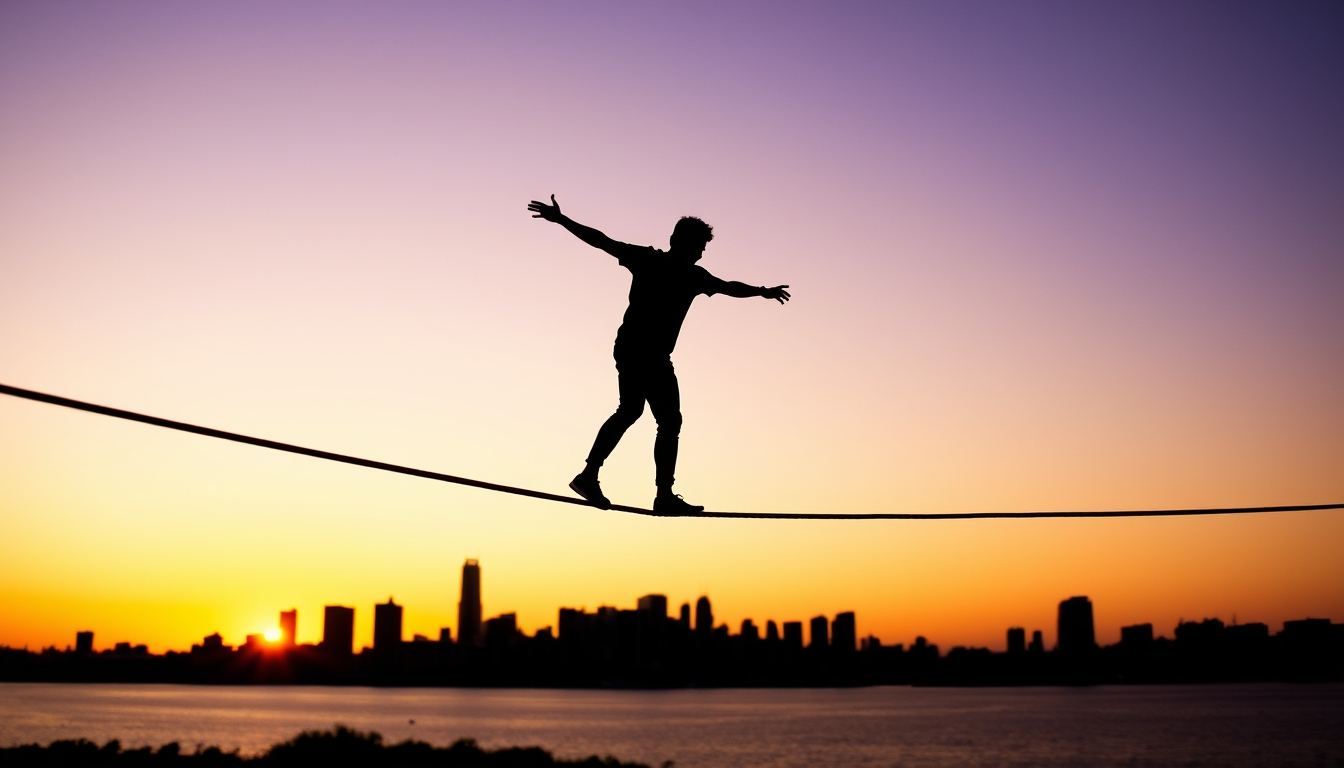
[527,195,789,515]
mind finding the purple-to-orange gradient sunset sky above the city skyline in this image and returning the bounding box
[0,1,1344,651]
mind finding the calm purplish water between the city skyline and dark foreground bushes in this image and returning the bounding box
[0,683,1344,768]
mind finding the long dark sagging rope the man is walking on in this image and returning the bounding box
[0,385,1344,521]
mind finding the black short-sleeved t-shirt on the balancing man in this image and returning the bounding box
[612,242,724,359]
